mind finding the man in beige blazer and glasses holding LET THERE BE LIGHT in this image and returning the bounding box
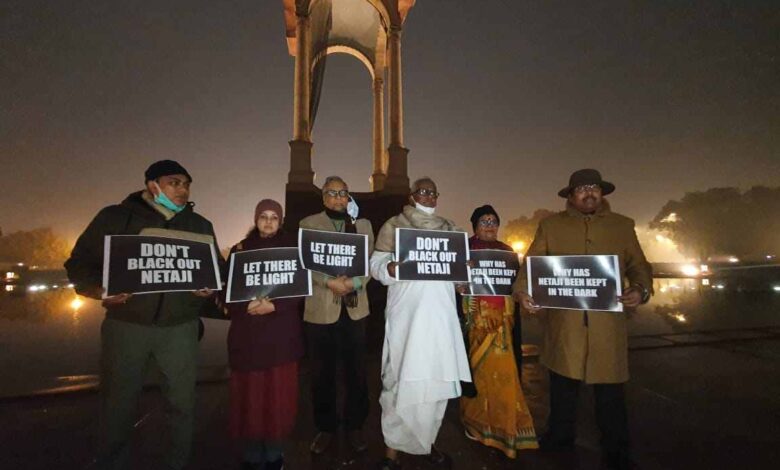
[300,176,374,454]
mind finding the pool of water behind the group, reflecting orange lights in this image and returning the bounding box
[0,275,780,397]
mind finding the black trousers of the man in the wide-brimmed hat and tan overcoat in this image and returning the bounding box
[545,371,629,455]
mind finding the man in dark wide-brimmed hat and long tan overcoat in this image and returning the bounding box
[514,169,653,468]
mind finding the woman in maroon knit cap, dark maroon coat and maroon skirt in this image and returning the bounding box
[227,199,304,470]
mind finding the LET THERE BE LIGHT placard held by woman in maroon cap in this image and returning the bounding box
[226,247,311,303]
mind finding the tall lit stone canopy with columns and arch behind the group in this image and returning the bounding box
[282,0,416,230]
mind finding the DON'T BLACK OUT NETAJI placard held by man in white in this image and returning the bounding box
[395,228,471,282]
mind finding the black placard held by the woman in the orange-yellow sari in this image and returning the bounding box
[469,250,520,296]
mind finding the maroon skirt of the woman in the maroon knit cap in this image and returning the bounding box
[230,362,298,440]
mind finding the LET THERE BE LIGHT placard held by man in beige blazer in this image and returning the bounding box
[298,228,368,277]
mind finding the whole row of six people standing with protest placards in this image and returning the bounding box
[65,160,652,470]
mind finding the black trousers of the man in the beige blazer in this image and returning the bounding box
[306,306,368,432]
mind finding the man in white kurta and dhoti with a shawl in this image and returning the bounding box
[371,179,471,468]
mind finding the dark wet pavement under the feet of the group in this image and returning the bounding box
[0,329,780,470]
